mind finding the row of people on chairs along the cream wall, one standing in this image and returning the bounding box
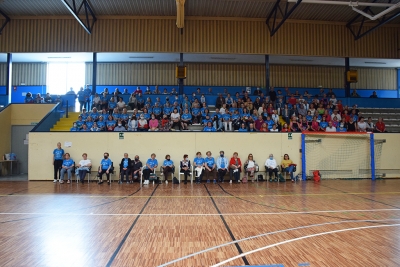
[53,143,296,184]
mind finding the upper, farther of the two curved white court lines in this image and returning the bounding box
[159,219,400,267]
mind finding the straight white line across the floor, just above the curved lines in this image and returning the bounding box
[0,209,400,216]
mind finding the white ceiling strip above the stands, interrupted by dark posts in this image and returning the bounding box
[0,53,400,68]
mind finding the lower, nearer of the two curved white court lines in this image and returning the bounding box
[211,224,400,267]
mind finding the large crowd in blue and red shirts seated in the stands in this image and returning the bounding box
[70,87,386,132]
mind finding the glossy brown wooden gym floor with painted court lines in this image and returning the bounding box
[0,179,400,267]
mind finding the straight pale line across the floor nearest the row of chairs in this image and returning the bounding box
[0,191,400,198]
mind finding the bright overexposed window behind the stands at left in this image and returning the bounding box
[47,62,85,95]
